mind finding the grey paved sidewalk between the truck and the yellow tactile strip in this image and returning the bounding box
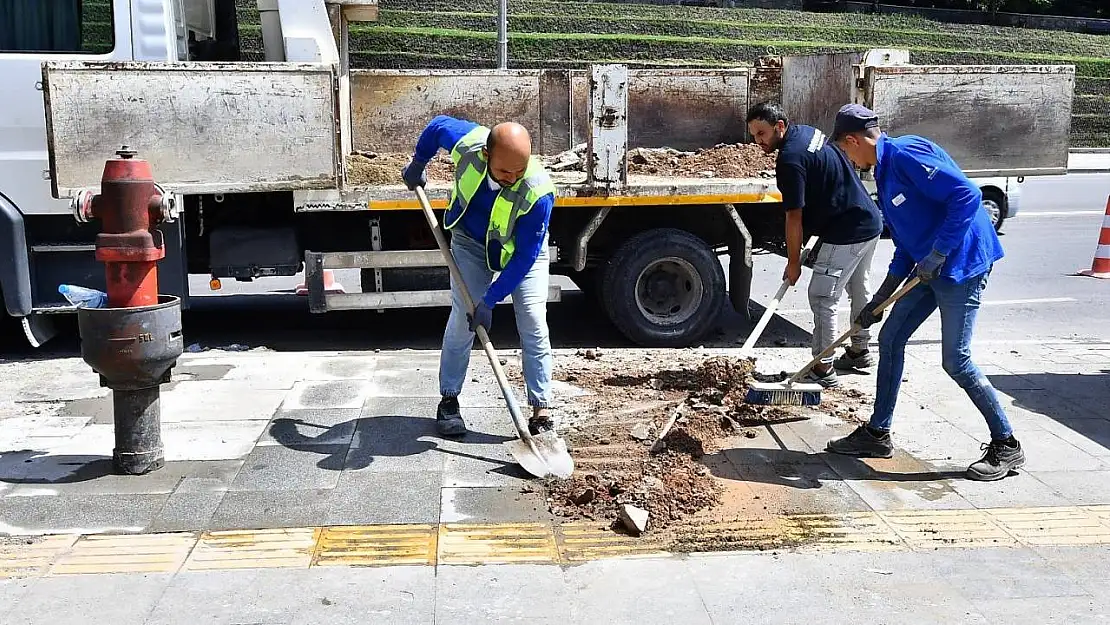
[0,341,1110,534]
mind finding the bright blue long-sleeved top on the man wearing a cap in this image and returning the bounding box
[875,133,1005,282]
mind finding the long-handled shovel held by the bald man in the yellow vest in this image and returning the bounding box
[416,187,574,478]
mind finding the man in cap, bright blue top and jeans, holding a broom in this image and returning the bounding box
[827,104,1026,481]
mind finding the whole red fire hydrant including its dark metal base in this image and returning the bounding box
[73,145,184,475]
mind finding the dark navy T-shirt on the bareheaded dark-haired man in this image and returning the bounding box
[775,123,882,245]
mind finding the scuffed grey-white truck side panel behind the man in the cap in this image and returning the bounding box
[866,65,1076,177]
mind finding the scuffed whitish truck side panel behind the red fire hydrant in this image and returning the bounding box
[42,62,342,196]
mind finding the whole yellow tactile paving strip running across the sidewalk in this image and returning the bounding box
[10,505,1110,578]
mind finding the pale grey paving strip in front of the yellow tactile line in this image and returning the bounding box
[0,546,1110,625]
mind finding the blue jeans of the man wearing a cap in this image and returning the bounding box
[870,270,1013,441]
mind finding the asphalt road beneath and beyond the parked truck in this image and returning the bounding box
[6,174,1110,356]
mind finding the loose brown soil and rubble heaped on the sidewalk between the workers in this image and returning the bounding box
[509,350,858,533]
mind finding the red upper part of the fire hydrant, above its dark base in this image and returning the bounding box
[73,145,175,309]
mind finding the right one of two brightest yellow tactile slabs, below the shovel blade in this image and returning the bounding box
[437,523,558,564]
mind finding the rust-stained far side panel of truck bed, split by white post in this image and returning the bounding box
[351,69,751,154]
